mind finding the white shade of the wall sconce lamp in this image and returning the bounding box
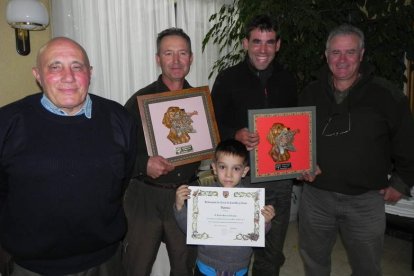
[6,0,49,31]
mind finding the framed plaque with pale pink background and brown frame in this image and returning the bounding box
[137,86,219,166]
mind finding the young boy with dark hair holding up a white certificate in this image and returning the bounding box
[174,139,275,276]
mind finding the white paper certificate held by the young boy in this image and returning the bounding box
[187,186,265,247]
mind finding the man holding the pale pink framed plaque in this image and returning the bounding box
[124,28,200,276]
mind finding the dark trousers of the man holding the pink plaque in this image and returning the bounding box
[123,179,196,276]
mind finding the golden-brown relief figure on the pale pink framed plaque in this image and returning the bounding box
[162,106,198,145]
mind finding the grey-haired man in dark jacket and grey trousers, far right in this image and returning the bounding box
[299,25,414,276]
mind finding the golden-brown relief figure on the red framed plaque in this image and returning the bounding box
[267,123,299,162]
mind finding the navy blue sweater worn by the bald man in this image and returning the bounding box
[0,93,136,275]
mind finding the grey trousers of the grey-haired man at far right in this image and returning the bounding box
[299,184,385,276]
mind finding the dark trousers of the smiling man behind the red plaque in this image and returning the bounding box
[249,180,293,276]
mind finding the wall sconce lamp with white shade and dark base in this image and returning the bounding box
[6,0,49,56]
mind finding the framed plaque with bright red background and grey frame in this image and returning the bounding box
[248,106,316,183]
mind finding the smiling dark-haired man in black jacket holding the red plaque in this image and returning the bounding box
[212,15,297,276]
